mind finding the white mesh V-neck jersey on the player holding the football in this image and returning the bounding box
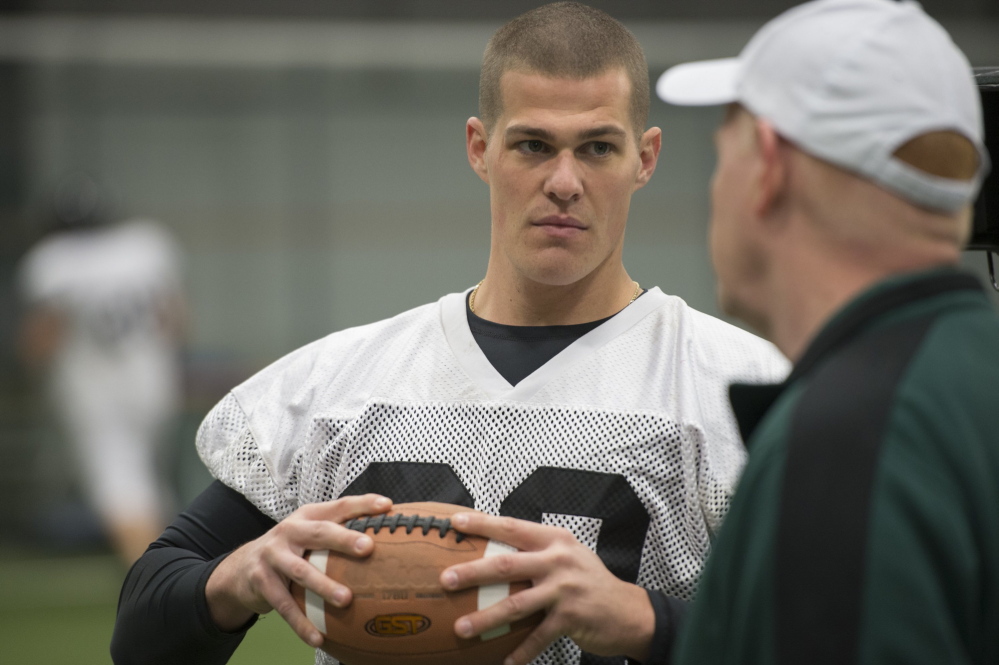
[198,288,789,664]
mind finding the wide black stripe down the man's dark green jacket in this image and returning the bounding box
[774,316,935,665]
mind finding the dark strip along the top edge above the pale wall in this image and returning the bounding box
[0,0,999,21]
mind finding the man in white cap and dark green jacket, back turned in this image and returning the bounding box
[657,0,999,665]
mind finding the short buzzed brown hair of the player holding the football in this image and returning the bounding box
[479,2,649,137]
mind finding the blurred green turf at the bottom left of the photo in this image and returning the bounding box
[0,556,313,665]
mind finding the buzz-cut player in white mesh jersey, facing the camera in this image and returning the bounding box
[112,3,787,665]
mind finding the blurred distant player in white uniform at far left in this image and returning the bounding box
[20,175,184,565]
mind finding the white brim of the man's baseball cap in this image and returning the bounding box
[656,58,741,106]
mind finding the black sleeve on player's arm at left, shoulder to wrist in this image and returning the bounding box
[111,481,277,665]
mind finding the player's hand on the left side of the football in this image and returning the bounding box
[205,494,392,647]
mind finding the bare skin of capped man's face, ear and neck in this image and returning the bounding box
[711,104,970,358]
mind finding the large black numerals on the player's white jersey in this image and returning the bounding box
[343,462,649,665]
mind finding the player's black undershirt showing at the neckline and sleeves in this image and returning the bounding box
[111,291,685,665]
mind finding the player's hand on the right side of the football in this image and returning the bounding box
[441,513,655,665]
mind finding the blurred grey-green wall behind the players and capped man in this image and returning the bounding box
[0,0,999,572]
